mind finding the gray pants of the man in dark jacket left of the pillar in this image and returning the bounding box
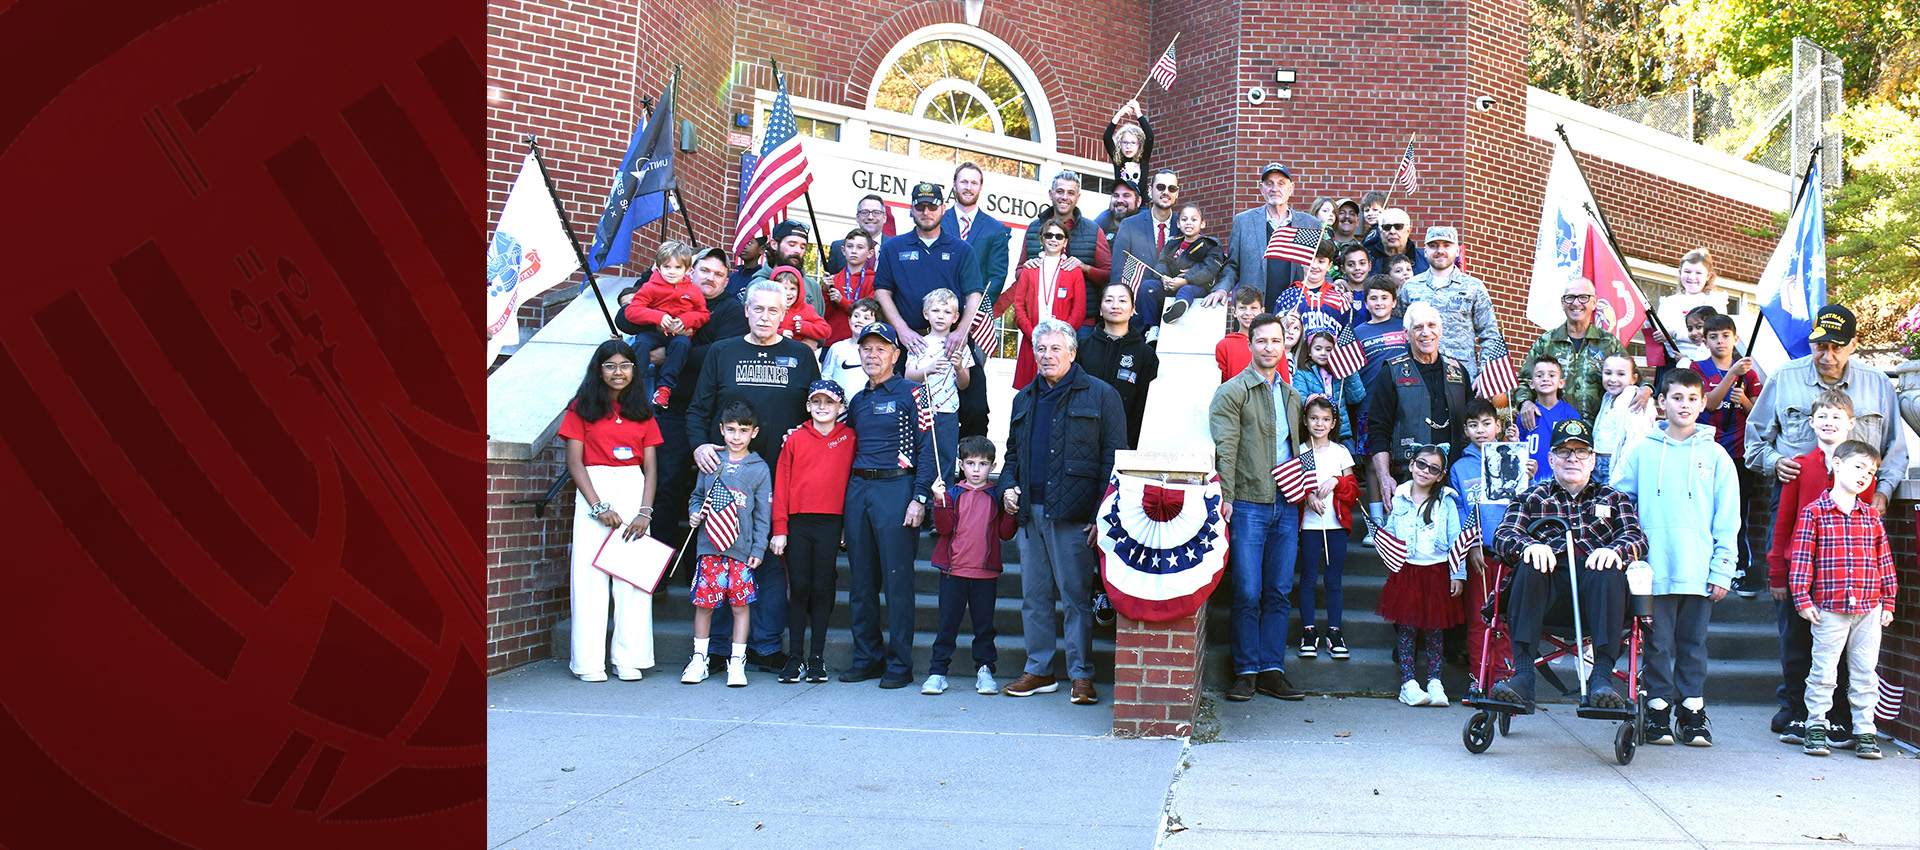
[1018,505,1098,679]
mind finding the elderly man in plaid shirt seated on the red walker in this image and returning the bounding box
[1488,418,1647,712]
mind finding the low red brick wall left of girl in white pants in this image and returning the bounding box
[486,441,574,673]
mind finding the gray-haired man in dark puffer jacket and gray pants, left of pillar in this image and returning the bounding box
[1000,319,1127,706]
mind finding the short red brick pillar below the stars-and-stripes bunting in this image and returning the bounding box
[1114,604,1206,739]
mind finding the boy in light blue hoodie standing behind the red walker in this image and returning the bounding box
[1613,368,1740,746]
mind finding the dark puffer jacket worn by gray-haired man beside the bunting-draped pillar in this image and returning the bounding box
[996,368,1127,524]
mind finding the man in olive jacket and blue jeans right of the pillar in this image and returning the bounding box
[1208,313,1306,702]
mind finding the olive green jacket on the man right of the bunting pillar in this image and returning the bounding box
[1206,366,1308,505]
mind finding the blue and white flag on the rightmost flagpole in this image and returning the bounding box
[1751,159,1826,374]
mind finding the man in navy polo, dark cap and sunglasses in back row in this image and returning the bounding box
[874,182,987,353]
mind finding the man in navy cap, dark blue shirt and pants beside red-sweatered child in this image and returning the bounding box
[841,322,933,689]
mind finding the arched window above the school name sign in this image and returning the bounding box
[874,38,1041,142]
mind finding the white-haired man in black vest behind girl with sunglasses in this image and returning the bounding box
[1367,301,1473,493]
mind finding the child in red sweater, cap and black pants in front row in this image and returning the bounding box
[768,380,854,683]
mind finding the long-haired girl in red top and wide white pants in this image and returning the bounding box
[561,340,664,681]
